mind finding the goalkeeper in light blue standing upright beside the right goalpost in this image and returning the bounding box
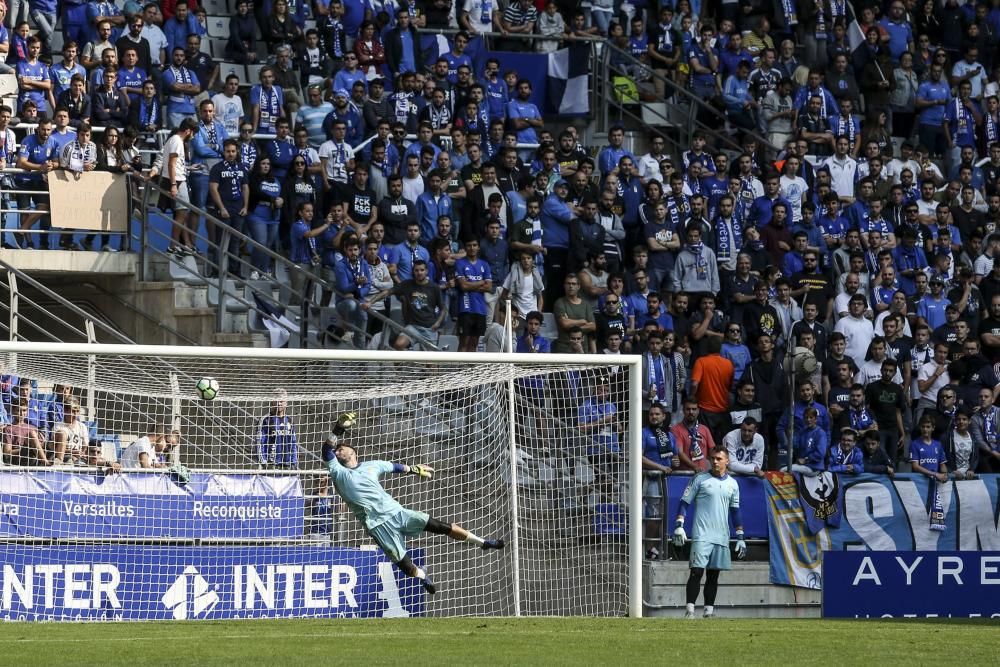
[673,449,747,618]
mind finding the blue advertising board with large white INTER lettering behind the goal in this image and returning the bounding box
[0,545,426,621]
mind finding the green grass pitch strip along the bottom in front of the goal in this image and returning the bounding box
[0,610,997,667]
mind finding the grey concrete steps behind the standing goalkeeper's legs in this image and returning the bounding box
[642,560,821,618]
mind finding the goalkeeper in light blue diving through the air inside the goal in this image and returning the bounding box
[323,412,504,595]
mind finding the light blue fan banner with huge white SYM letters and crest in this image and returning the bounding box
[764,473,1000,589]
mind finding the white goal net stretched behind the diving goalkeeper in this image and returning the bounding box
[0,343,640,620]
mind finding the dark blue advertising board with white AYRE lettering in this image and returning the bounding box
[823,551,1000,618]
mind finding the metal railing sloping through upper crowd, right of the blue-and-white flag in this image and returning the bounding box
[597,42,782,157]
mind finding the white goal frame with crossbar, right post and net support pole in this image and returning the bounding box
[0,341,643,618]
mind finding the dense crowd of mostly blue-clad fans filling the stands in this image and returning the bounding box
[0,0,1000,498]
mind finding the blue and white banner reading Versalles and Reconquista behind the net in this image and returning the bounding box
[0,471,304,539]
